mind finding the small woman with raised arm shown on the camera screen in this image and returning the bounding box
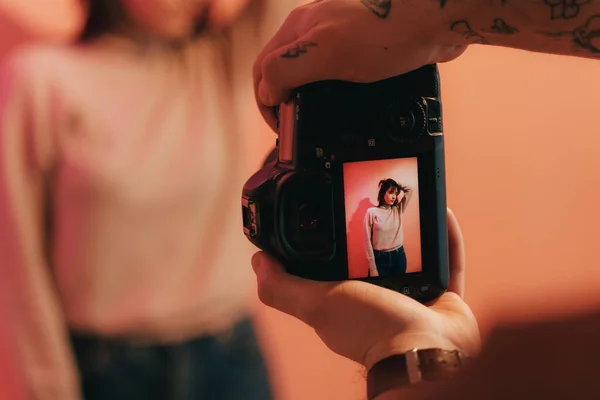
[364,178,412,277]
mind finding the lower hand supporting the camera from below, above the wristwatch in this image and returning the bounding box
[252,211,480,369]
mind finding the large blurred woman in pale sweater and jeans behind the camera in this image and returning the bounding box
[0,0,292,400]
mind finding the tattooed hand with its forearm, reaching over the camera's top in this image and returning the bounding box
[254,0,600,129]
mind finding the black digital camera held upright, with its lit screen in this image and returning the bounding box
[242,65,449,302]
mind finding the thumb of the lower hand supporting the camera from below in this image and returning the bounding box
[252,252,335,326]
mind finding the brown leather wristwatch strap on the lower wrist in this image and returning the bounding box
[367,349,470,400]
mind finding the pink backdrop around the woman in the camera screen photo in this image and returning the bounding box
[344,158,421,278]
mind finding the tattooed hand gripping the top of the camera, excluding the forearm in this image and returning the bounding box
[254,0,466,129]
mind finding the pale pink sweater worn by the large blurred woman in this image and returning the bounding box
[0,2,291,400]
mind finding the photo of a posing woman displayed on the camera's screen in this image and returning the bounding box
[344,157,422,279]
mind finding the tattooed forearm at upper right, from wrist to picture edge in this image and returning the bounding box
[439,0,600,59]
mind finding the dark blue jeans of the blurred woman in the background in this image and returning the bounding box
[72,320,272,400]
